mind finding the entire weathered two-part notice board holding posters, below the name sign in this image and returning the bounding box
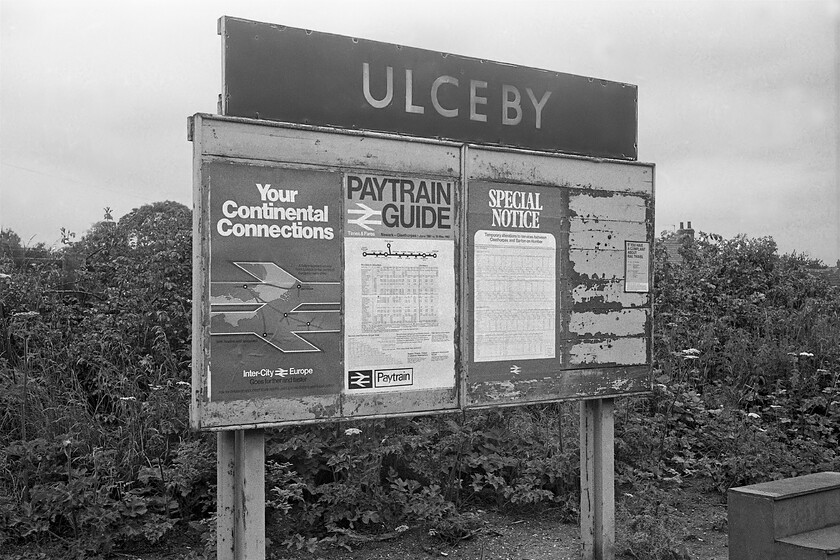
[190,115,654,430]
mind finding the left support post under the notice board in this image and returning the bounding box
[216,430,265,560]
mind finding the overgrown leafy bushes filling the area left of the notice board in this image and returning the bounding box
[0,202,214,554]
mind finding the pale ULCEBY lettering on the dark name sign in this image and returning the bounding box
[362,62,551,129]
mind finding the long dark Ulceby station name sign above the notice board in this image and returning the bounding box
[219,17,637,160]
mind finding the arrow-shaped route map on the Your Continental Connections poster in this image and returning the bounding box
[210,262,341,353]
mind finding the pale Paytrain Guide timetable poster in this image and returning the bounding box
[344,174,456,392]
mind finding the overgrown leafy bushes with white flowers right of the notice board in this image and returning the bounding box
[616,234,840,560]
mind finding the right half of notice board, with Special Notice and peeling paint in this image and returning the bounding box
[463,147,653,407]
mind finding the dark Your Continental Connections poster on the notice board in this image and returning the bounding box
[207,163,341,401]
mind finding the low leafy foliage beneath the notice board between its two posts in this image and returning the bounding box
[266,405,579,547]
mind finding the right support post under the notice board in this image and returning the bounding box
[580,399,615,560]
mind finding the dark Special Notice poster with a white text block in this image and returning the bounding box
[467,181,564,383]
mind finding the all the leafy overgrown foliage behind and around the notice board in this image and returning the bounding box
[0,211,840,560]
